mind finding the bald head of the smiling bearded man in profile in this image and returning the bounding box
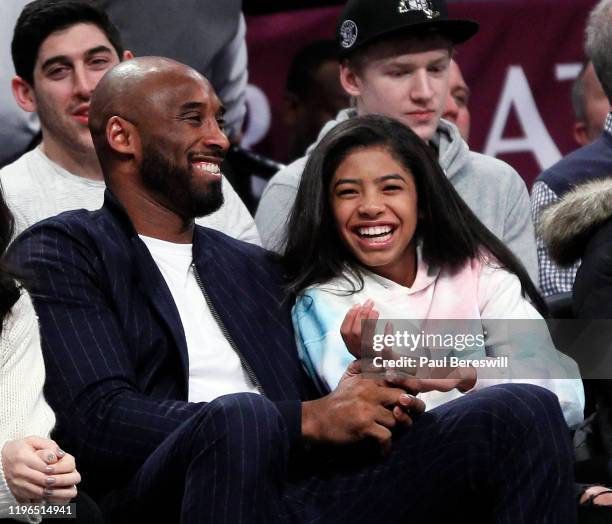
[89,57,229,219]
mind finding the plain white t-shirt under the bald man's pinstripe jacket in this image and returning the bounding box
[140,235,259,402]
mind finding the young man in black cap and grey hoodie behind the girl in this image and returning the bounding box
[255,0,537,280]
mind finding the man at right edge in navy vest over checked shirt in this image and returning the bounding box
[531,0,612,296]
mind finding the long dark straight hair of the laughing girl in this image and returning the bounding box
[283,115,547,316]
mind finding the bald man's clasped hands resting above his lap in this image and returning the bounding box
[302,368,425,453]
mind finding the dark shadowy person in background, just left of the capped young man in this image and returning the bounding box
[283,40,350,161]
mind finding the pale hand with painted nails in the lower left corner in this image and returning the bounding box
[1,437,81,504]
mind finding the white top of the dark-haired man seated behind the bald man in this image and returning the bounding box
[0,147,261,245]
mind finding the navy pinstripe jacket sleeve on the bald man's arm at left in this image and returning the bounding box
[9,225,203,482]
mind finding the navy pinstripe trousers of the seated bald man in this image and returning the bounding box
[103,384,576,524]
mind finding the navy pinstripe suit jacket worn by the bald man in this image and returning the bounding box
[9,191,312,492]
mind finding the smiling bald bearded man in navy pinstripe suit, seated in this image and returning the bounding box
[11,57,575,524]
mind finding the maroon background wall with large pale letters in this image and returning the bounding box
[247,0,595,184]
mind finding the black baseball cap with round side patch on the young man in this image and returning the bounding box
[337,0,478,56]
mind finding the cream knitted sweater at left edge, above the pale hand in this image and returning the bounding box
[0,291,55,522]
